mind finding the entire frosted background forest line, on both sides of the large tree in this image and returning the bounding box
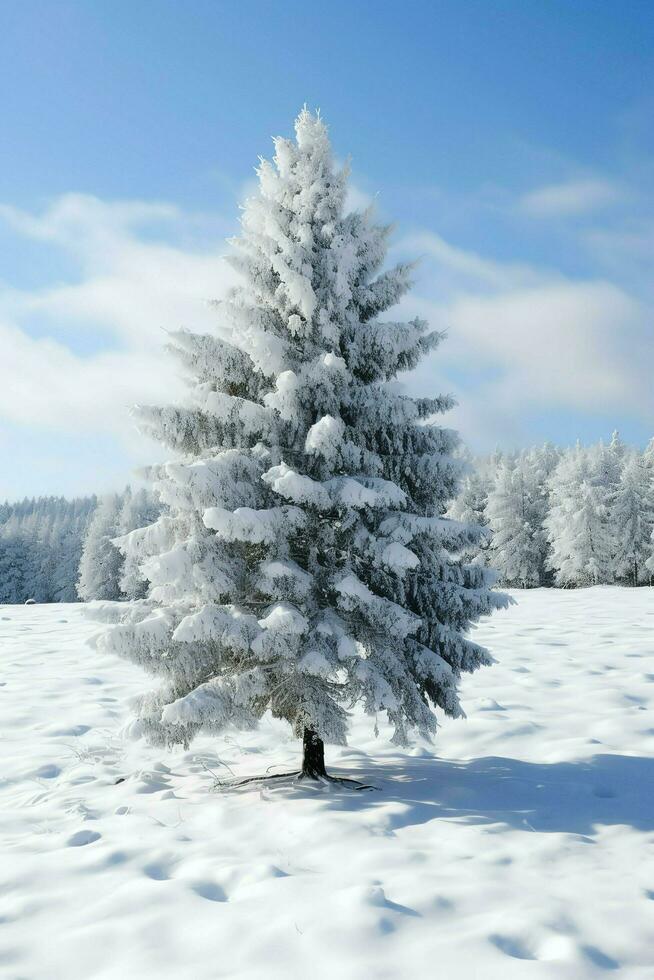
[0,433,654,603]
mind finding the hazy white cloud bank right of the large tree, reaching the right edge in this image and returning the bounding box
[406,233,654,447]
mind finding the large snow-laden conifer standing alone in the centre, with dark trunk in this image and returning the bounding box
[101,110,505,778]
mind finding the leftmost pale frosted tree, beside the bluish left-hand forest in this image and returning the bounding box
[77,493,123,601]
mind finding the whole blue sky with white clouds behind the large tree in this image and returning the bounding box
[0,0,654,497]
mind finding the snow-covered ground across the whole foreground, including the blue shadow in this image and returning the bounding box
[0,588,654,980]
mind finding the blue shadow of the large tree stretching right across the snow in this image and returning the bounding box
[326,755,654,835]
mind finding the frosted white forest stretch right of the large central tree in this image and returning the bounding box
[448,432,654,589]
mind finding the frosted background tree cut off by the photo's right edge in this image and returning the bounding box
[611,454,654,585]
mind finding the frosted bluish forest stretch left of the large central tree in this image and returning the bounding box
[0,487,160,603]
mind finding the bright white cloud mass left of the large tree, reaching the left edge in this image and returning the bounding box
[0,194,238,438]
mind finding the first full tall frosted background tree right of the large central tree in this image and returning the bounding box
[486,456,542,589]
